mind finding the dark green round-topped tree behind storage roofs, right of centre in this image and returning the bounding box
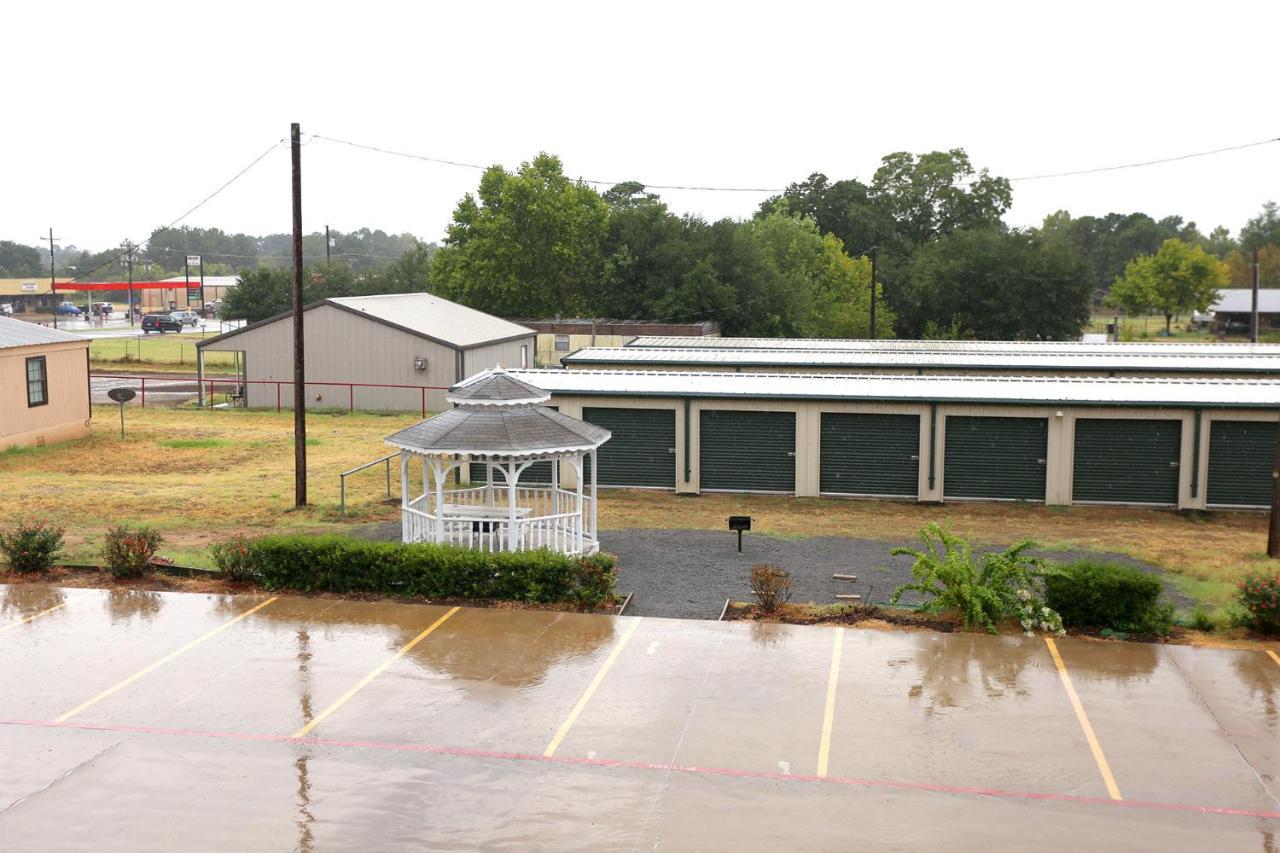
[895,228,1092,341]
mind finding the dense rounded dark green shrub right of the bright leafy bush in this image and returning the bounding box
[1044,560,1174,635]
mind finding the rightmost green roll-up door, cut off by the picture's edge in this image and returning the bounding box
[1204,420,1276,506]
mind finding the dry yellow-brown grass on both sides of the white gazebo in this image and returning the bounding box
[0,407,1276,607]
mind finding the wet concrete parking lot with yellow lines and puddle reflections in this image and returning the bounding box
[0,585,1280,850]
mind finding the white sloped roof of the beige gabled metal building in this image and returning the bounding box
[325,293,536,347]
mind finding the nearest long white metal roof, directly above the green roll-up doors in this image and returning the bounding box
[509,370,1280,410]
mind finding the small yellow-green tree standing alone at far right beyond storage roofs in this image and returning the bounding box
[1107,238,1230,334]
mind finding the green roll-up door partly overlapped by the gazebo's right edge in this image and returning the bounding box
[582,409,676,489]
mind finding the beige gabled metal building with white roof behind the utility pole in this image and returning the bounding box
[196,293,535,412]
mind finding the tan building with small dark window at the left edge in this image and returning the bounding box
[0,316,92,451]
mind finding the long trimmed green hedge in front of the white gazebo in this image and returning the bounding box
[215,535,617,606]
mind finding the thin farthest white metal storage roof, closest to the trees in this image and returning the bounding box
[626,336,1280,356]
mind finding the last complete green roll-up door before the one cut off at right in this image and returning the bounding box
[1071,418,1183,505]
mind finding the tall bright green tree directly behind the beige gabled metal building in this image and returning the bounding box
[431,154,608,318]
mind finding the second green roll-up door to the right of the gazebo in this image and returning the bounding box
[698,410,796,492]
